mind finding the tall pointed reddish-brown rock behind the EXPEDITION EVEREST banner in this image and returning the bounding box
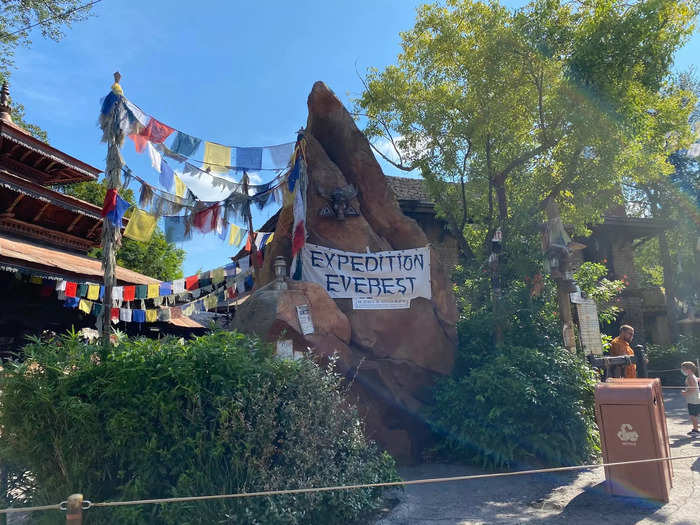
[258,82,457,461]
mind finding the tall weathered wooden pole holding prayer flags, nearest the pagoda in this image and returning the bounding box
[98,71,122,346]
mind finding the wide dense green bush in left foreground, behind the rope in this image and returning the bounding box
[0,332,396,524]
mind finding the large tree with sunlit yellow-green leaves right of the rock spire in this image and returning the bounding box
[357,0,698,342]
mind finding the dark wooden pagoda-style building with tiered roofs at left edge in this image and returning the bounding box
[0,84,202,355]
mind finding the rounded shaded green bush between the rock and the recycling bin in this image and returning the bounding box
[429,346,598,468]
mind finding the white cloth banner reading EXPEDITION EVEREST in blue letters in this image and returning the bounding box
[302,243,431,299]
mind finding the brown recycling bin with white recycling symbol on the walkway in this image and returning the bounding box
[595,379,672,502]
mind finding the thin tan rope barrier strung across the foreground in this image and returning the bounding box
[0,454,700,514]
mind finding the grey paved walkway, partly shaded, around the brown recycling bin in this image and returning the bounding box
[376,391,700,525]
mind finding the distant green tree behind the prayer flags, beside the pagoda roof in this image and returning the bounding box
[60,179,185,281]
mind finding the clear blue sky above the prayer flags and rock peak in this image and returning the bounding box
[6,0,700,275]
